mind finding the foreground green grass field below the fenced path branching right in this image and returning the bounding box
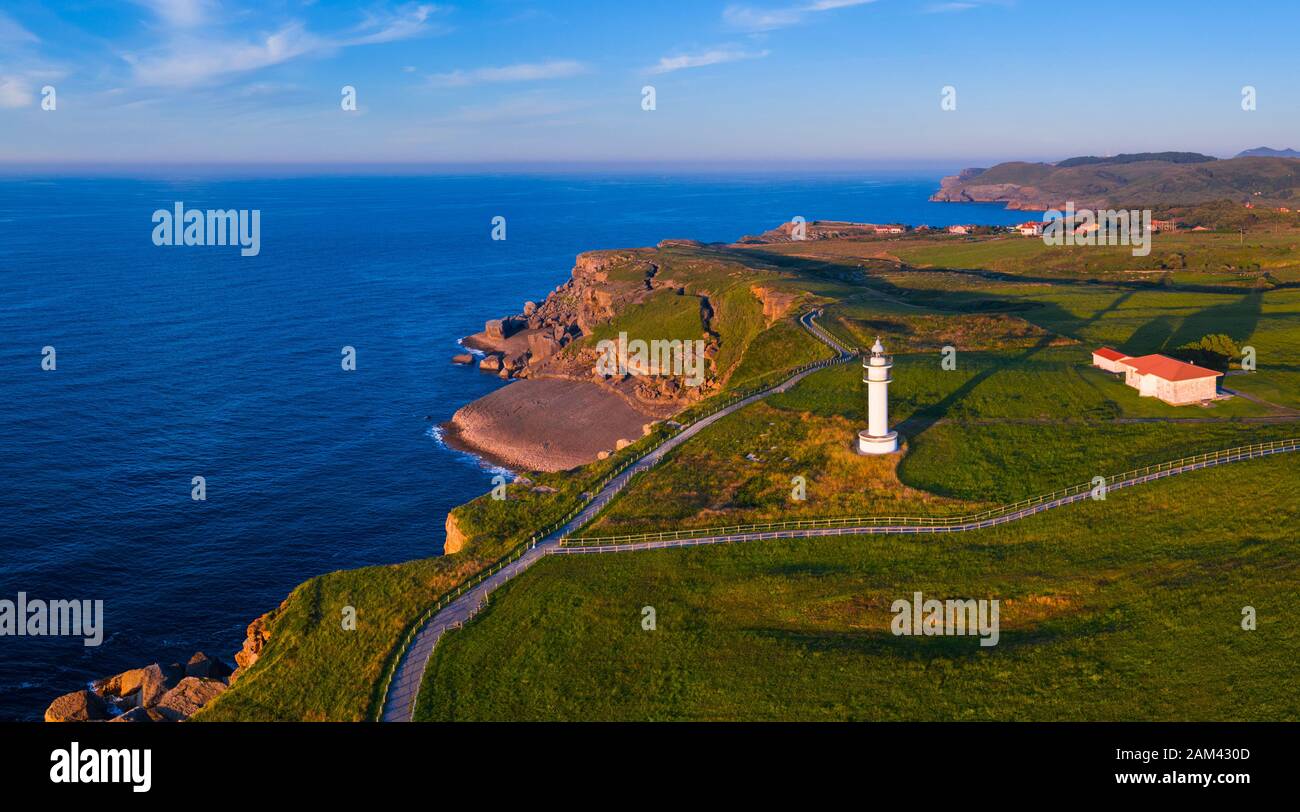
[417,457,1300,720]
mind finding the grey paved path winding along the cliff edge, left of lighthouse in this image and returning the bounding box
[380,311,855,722]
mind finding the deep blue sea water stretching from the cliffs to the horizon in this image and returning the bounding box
[0,174,1024,718]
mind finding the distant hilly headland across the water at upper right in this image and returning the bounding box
[931,152,1300,209]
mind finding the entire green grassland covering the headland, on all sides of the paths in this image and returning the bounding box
[205,233,1300,720]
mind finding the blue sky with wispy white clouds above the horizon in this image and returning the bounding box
[0,0,1300,166]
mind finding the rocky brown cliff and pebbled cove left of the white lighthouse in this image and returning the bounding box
[442,240,738,467]
